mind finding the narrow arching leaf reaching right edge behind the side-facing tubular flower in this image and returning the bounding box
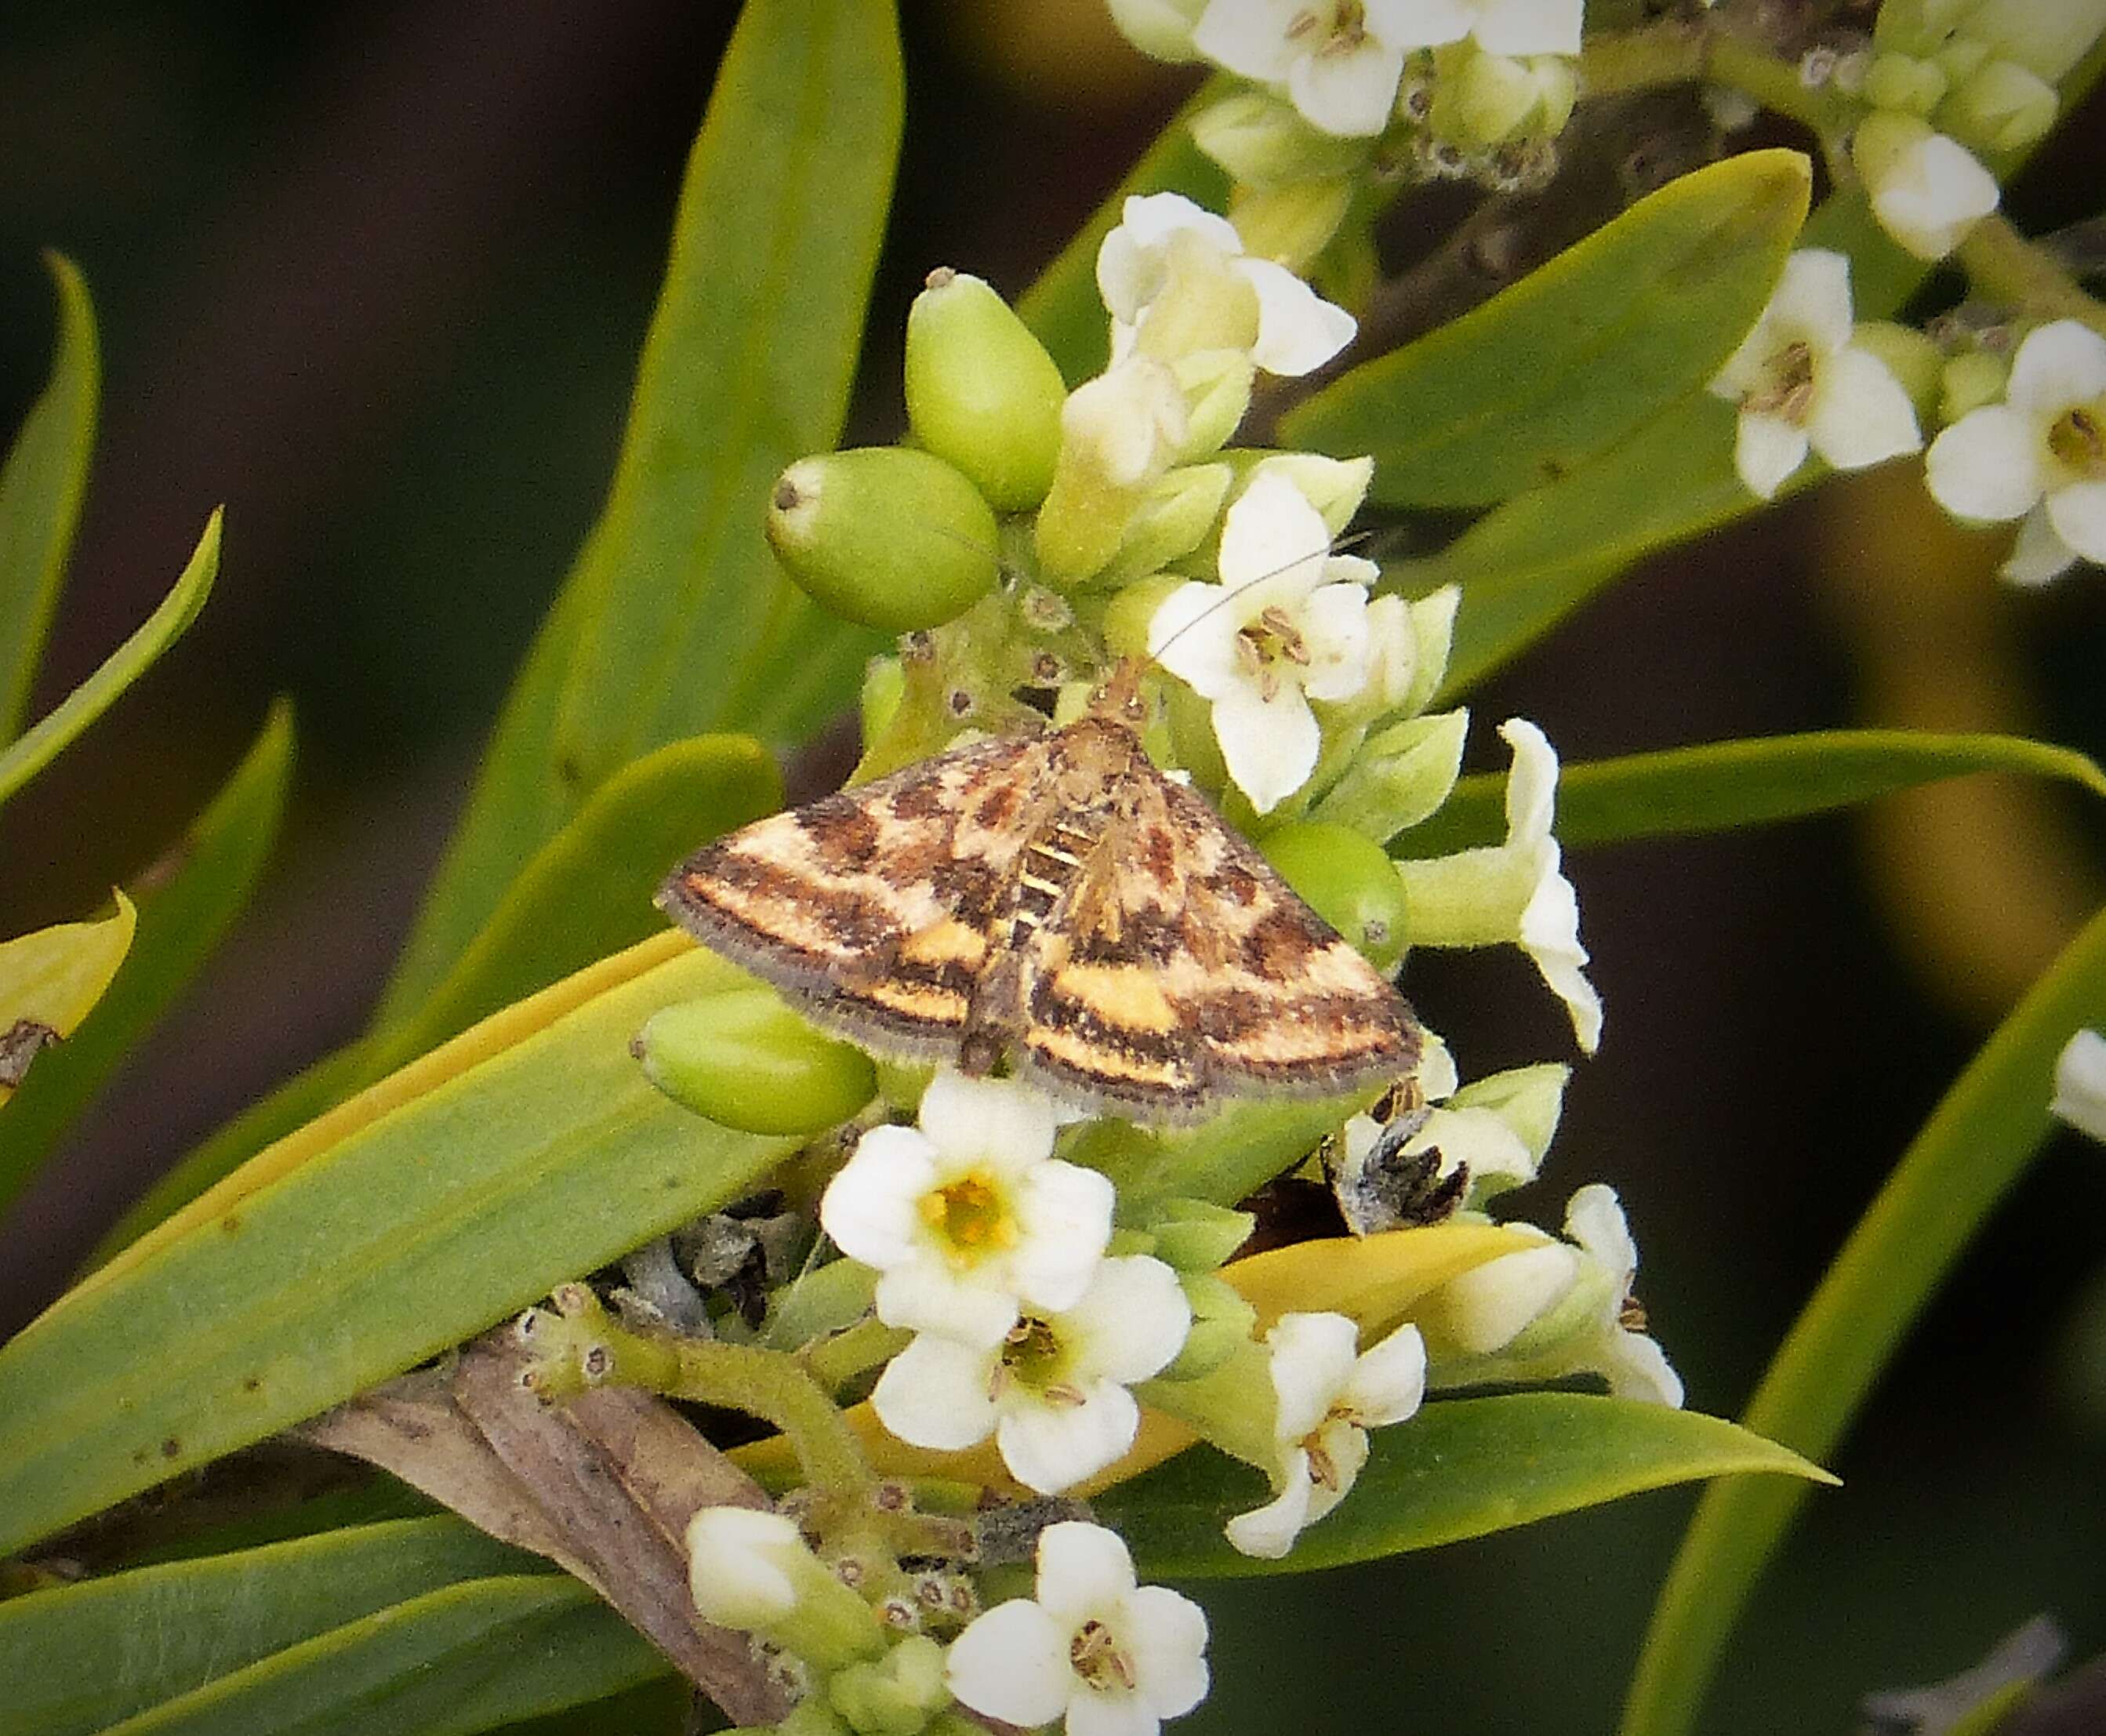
[1396,729,2106,855]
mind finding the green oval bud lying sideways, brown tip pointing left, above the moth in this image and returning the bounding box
[767,447,1000,632]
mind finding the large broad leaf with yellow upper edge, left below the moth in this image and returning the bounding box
[0,938,788,1555]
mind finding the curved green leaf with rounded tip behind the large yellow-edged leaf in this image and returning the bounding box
[93,735,782,1258]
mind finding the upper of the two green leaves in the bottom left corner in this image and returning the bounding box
[0,1515,546,1736]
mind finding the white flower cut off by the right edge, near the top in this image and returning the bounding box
[1927,320,2106,583]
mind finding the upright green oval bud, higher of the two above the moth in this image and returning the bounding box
[906,267,1068,512]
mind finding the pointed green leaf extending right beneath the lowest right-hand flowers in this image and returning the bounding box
[1091,1393,1835,1578]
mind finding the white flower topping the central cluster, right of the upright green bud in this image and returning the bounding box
[1097,194,1358,375]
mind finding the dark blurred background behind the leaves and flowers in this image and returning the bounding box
[0,0,2106,1736]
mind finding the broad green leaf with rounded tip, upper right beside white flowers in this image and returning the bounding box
[1280,150,1811,506]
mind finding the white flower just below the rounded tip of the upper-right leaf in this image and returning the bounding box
[1710,246,1923,499]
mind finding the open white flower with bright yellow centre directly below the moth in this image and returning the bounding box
[819,1073,1112,1344]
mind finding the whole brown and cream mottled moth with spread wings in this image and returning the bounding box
[659,663,1419,1123]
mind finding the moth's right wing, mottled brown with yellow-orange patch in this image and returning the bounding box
[1017,757,1419,1119]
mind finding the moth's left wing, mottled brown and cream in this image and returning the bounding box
[659,737,1051,1060]
